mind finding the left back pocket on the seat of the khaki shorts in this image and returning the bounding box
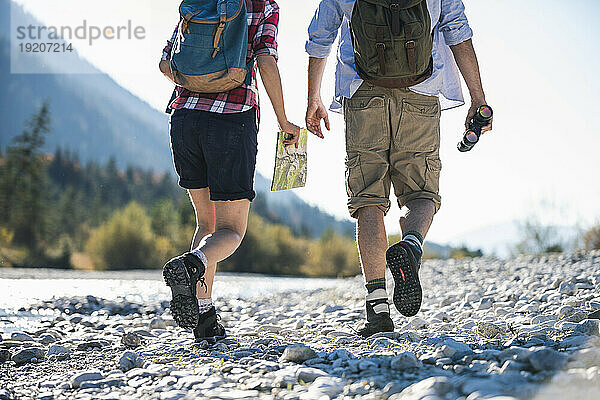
[344,96,390,151]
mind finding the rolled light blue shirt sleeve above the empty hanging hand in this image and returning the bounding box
[305,0,344,58]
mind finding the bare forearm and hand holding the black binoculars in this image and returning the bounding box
[450,39,492,133]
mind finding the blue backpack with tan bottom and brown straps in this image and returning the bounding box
[171,0,254,93]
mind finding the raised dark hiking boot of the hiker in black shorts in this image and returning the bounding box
[163,253,206,329]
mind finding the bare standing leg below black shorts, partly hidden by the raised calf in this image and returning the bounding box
[188,188,217,299]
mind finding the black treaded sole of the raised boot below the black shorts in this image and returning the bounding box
[163,259,199,329]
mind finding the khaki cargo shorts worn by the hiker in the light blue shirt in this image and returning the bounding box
[344,82,442,218]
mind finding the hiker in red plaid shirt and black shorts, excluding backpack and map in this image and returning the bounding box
[160,0,300,340]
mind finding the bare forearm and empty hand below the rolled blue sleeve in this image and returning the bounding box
[305,57,330,139]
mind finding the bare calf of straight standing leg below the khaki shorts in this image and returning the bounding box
[356,206,388,282]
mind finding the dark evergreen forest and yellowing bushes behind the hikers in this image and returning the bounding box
[0,104,360,276]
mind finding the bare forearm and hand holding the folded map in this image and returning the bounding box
[256,55,300,147]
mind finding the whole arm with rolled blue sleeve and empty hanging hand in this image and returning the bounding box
[305,0,344,138]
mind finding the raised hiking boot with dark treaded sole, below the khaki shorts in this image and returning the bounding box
[385,241,423,317]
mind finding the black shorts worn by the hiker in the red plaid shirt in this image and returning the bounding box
[171,108,258,201]
